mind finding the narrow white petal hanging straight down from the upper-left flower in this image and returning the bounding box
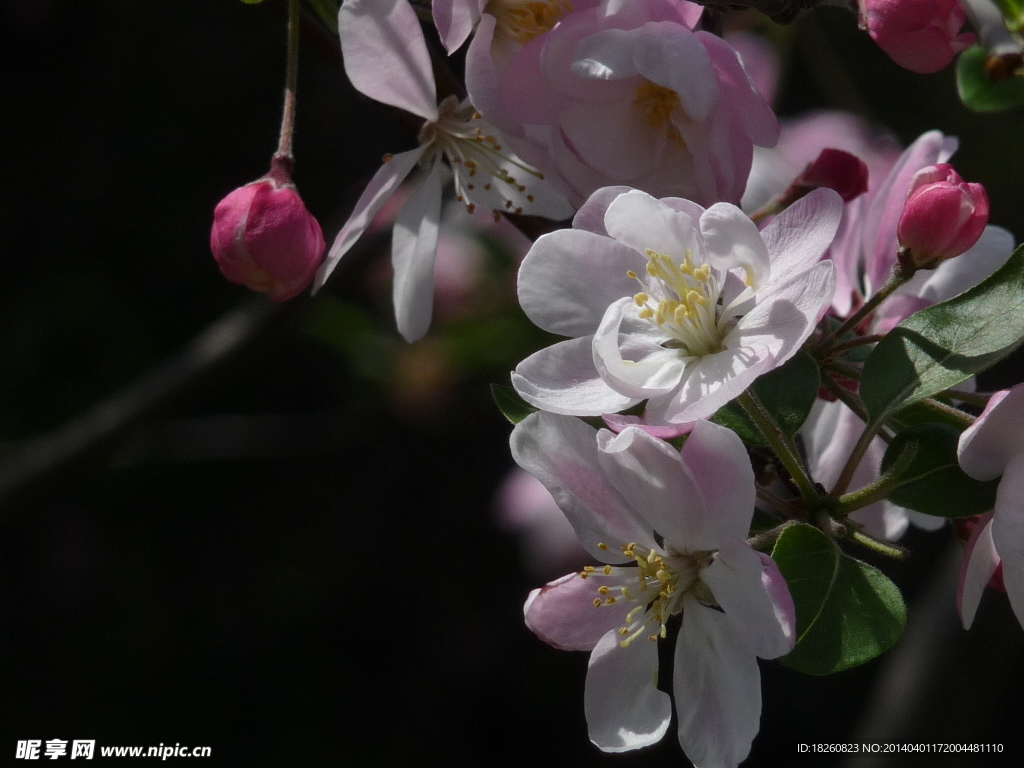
[391,161,441,342]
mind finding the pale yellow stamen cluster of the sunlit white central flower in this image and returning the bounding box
[626,248,724,356]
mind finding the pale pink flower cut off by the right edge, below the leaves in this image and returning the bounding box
[956,384,1024,629]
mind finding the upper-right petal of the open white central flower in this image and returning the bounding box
[761,187,843,284]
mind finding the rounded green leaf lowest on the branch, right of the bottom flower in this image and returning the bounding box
[772,524,906,675]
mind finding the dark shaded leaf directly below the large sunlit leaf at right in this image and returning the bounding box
[882,424,999,517]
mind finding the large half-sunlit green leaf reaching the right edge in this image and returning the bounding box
[860,246,1024,421]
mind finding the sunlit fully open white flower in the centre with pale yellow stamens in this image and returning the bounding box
[512,187,843,436]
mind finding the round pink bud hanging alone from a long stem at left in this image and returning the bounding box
[210,159,327,301]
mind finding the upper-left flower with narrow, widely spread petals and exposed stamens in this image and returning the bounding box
[313,0,572,341]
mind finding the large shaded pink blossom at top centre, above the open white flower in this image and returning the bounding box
[487,0,778,206]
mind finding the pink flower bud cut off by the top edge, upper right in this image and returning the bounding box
[860,0,974,75]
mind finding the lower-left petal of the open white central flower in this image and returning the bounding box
[512,336,640,416]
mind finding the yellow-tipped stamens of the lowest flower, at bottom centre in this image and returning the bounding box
[580,542,715,648]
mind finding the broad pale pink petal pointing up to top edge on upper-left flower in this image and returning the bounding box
[338,0,437,120]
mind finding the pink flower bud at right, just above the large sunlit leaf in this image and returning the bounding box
[896,163,988,269]
